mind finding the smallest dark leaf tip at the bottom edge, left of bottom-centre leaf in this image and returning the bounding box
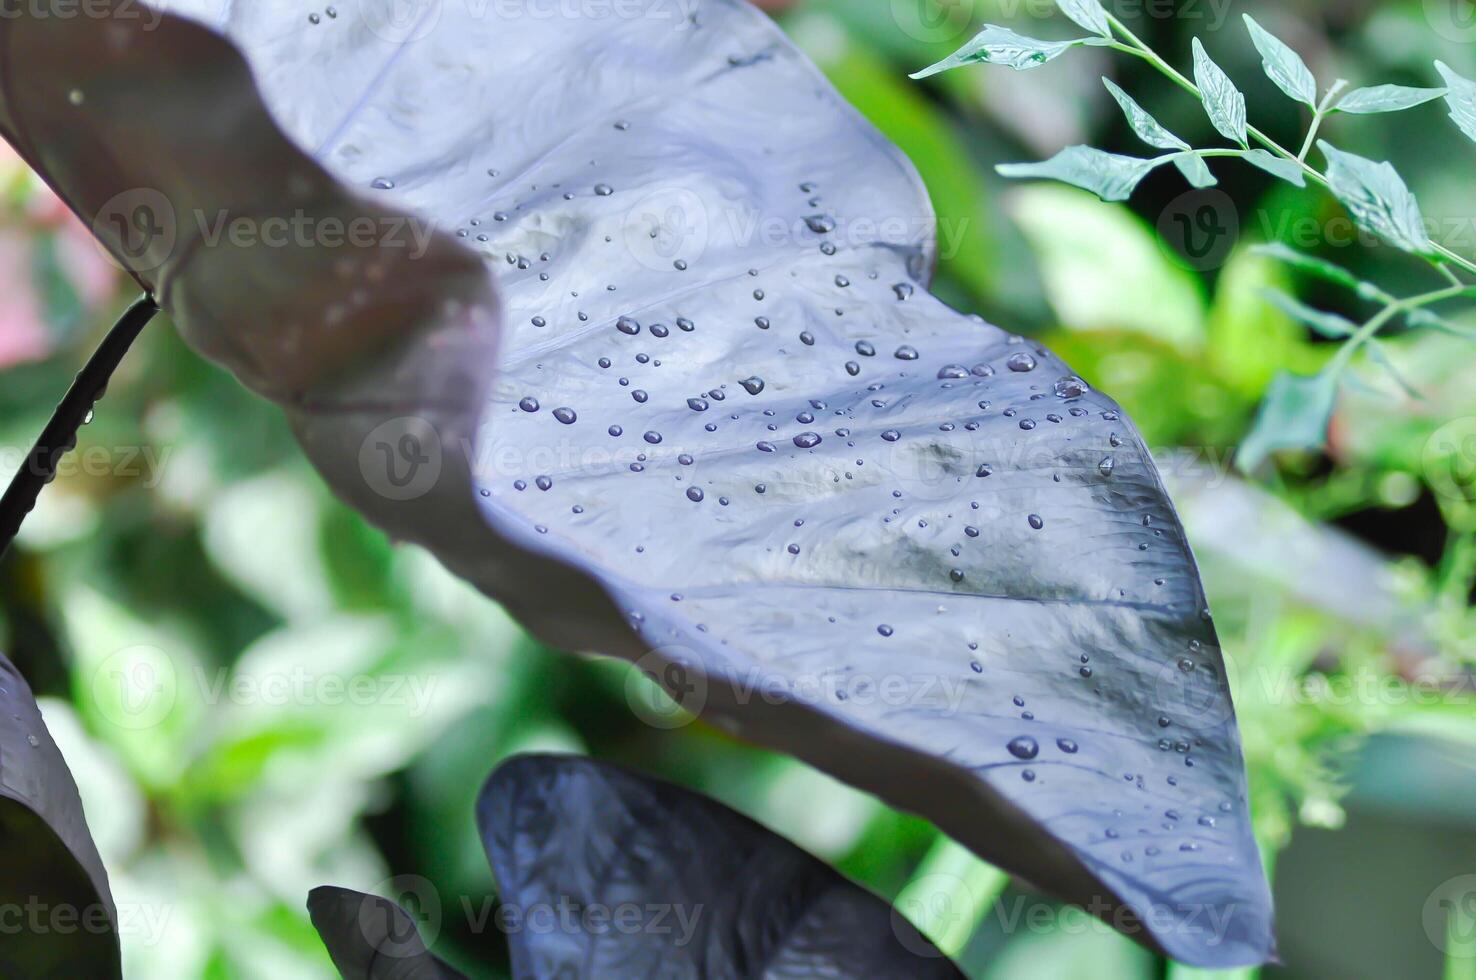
[307,886,462,980]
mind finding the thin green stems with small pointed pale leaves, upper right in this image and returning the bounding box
[914,0,1476,471]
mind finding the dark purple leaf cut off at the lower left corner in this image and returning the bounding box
[0,654,121,979]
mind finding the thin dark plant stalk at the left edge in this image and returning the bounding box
[0,295,159,556]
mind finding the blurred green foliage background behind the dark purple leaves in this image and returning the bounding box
[0,0,1476,980]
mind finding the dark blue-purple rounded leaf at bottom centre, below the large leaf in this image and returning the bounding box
[477,756,962,980]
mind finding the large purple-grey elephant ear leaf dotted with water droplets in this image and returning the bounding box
[0,0,1272,965]
